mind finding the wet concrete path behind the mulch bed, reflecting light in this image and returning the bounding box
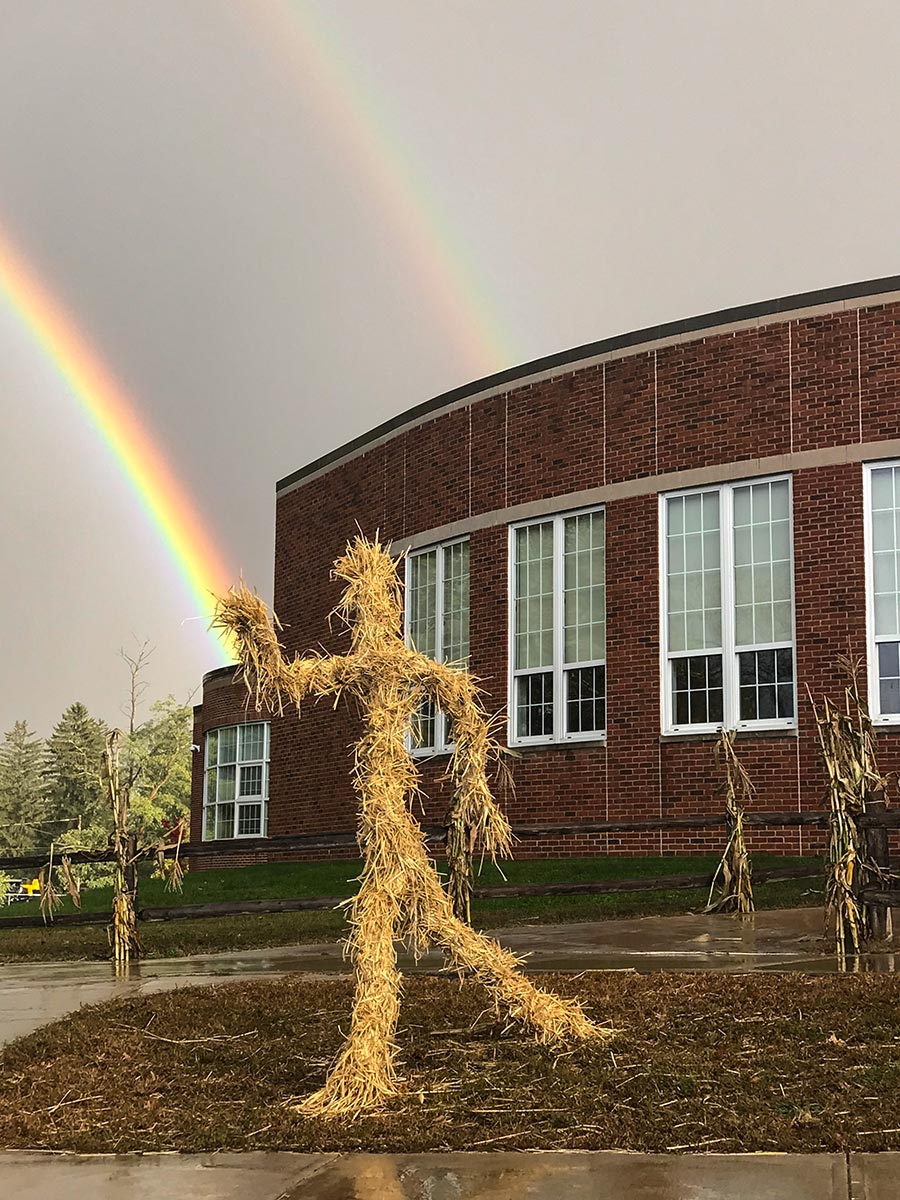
[0,908,900,1044]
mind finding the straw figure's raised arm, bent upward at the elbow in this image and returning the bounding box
[211,582,359,713]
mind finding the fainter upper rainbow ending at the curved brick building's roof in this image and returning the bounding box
[257,0,527,376]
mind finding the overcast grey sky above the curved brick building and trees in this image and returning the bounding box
[0,0,900,733]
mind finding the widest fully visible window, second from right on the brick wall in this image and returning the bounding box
[660,476,796,733]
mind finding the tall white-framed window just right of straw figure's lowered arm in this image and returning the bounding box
[509,509,606,745]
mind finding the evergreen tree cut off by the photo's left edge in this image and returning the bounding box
[0,721,47,854]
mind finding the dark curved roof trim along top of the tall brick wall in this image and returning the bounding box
[275,275,900,492]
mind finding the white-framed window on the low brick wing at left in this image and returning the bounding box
[203,721,269,841]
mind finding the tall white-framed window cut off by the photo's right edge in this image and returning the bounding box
[864,462,900,724]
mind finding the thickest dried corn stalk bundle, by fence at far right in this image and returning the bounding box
[808,655,888,961]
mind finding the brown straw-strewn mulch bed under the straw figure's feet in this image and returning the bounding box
[0,972,900,1152]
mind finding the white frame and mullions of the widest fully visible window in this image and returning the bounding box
[659,473,797,738]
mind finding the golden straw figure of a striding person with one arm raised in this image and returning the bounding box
[214,536,612,1115]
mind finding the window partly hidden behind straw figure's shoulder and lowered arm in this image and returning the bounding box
[406,538,469,754]
